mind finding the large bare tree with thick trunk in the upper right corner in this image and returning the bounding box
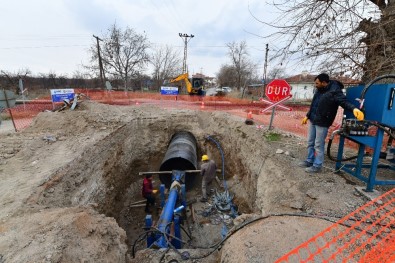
[254,0,395,82]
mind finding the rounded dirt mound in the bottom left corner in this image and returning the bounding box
[0,207,127,262]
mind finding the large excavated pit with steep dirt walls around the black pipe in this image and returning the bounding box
[21,105,266,262]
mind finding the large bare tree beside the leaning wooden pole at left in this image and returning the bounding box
[90,23,149,90]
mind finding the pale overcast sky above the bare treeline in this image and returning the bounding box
[0,0,288,76]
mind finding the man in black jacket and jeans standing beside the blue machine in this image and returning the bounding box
[299,73,364,173]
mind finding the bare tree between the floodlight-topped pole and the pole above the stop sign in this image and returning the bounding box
[227,41,254,90]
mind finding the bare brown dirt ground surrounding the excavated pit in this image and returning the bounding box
[0,101,378,262]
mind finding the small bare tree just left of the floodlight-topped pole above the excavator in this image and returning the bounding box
[151,45,182,89]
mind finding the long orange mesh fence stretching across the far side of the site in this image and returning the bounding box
[5,89,356,145]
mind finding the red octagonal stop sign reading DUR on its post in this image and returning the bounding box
[265,79,292,130]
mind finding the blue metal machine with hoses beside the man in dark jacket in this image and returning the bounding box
[334,75,395,192]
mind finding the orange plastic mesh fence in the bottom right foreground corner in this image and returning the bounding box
[276,189,395,263]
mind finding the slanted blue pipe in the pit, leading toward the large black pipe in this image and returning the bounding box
[156,189,178,248]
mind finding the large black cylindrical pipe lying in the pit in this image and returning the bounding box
[159,131,197,189]
